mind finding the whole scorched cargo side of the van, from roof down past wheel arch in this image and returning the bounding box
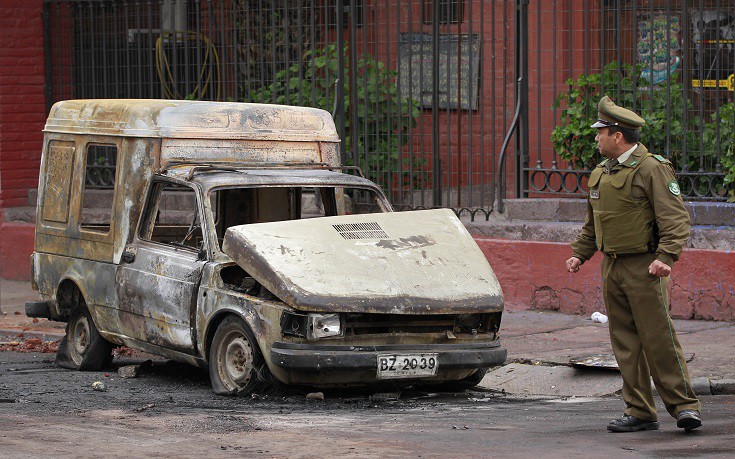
[33,133,161,316]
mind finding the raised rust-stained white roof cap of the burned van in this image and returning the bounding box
[44,99,339,142]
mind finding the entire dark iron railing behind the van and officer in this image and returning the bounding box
[44,0,735,218]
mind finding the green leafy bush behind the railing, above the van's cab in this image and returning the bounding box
[247,44,426,189]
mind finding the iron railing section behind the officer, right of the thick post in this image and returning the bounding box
[523,0,735,200]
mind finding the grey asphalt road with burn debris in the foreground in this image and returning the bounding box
[0,352,735,458]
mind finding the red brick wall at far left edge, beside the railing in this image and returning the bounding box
[0,0,46,279]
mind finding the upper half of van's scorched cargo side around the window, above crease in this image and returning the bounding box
[35,135,160,263]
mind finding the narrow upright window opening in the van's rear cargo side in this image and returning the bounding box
[79,143,118,233]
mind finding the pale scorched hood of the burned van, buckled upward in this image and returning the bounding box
[223,209,503,314]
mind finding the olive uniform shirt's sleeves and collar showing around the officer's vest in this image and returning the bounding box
[571,143,690,266]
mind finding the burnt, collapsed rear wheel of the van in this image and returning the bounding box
[56,295,114,371]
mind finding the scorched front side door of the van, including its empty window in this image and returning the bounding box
[117,179,207,353]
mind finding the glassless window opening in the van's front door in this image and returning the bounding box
[140,182,204,250]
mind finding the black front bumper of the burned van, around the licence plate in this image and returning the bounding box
[271,341,508,372]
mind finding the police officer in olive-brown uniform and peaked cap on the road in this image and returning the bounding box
[566,96,702,432]
